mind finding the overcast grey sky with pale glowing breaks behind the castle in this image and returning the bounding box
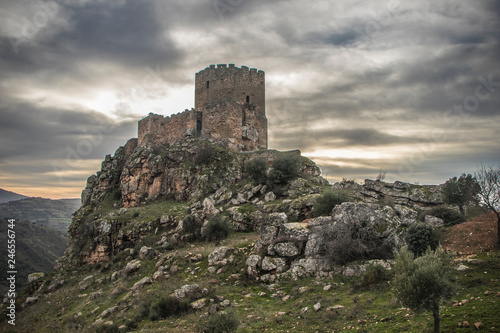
[0,0,500,198]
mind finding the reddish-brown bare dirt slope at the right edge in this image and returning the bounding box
[441,212,498,254]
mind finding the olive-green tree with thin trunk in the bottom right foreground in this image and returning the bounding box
[392,246,453,333]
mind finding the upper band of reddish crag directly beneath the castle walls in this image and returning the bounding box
[82,139,326,207]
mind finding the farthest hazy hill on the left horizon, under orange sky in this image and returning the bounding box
[0,198,80,235]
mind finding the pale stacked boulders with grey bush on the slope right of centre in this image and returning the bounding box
[246,202,417,282]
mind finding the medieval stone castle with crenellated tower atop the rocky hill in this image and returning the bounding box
[138,64,267,151]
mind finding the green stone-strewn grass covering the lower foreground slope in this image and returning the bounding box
[0,231,500,332]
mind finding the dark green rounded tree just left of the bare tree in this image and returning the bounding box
[443,173,481,216]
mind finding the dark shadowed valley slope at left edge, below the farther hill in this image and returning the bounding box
[0,219,66,295]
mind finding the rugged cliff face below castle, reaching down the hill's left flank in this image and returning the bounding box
[67,139,327,263]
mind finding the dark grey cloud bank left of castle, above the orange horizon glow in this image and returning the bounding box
[0,98,137,162]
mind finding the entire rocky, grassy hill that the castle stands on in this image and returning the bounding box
[0,139,500,332]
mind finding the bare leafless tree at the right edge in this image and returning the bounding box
[474,165,500,245]
